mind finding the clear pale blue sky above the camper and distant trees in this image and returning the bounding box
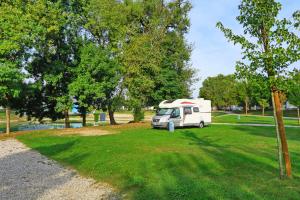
[187,0,300,97]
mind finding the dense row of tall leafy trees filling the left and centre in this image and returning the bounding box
[0,0,193,132]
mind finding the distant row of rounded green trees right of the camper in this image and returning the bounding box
[199,70,300,116]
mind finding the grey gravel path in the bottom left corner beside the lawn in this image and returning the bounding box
[0,139,118,200]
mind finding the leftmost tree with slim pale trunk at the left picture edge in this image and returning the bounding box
[0,1,31,134]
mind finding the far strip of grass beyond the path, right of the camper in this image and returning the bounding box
[212,114,298,126]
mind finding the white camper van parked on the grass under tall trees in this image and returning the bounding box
[152,98,211,128]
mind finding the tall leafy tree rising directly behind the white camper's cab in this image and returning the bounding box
[147,1,196,106]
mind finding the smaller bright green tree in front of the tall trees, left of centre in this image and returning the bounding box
[69,43,121,125]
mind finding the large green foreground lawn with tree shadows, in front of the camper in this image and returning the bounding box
[17,125,300,200]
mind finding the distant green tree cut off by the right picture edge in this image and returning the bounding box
[288,71,300,125]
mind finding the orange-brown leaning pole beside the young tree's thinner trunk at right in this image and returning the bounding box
[272,90,292,177]
